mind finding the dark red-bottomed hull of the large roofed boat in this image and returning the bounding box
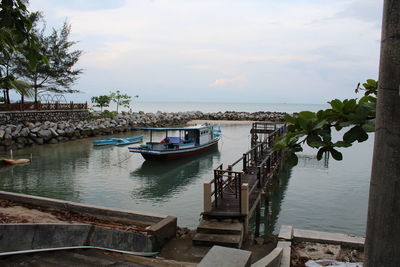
[140,140,218,161]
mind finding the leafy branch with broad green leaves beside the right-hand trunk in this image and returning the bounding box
[273,79,378,165]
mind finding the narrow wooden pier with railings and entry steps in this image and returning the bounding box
[193,122,286,248]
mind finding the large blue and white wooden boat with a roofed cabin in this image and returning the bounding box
[128,123,221,160]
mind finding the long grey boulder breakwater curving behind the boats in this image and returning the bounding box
[0,111,286,151]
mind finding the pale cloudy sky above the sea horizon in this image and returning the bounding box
[29,0,383,104]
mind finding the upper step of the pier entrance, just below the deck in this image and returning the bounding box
[197,220,243,235]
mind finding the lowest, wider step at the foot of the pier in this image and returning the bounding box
[193,233,242,248]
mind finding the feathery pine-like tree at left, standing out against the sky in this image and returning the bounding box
[16,19,82,102]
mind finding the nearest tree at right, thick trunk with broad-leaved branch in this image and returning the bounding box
[275,0,400,267]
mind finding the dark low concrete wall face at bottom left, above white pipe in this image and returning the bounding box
[0,223,157,252]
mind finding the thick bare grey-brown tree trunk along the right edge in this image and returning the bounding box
[365,0,400,267]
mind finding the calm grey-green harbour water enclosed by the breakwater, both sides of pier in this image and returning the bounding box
[0,102,373,235]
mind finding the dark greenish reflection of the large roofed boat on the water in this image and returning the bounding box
[131,148,220,200]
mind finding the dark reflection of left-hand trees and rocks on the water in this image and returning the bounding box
[0,141,91,201]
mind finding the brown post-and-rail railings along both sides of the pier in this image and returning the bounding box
[204,123,286,217]
